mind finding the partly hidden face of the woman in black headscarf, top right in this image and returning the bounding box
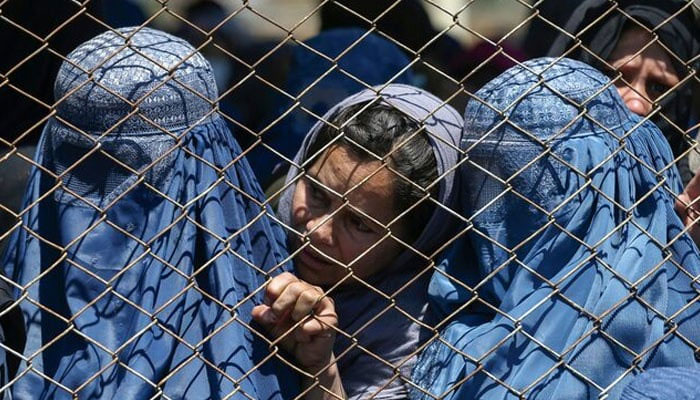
[609,27,679,116]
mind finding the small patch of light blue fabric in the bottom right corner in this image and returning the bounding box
[620,368,700,400]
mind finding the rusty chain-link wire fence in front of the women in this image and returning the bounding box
[0,0,700,399]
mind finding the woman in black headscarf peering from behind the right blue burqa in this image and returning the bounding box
[547,0,700,182]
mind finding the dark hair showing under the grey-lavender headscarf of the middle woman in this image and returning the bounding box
[306,103,438,242]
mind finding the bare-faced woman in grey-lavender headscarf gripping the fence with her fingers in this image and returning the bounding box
[254,84,462,399]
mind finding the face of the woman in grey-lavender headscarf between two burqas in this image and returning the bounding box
[291,145,403,285]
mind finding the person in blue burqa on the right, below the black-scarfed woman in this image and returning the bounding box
[413,58,700,400]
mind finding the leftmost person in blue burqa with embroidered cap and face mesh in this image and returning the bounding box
[3,28,298,399]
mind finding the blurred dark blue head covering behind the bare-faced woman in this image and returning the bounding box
[248,28,414,183]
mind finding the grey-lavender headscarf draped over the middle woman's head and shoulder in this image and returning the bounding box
[279,84,462,399]
